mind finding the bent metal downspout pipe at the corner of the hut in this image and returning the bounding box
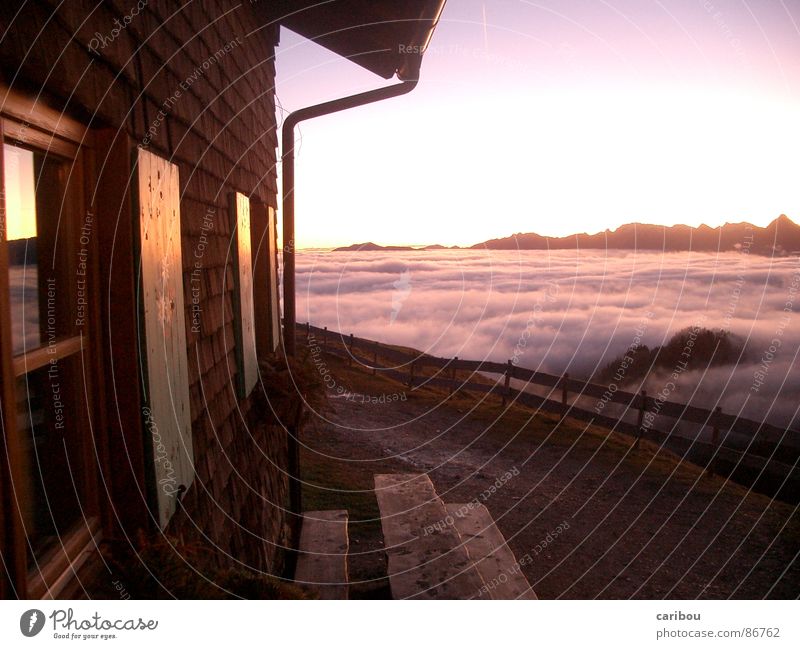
[281,75,418,356]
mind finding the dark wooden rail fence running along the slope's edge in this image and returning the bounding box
[298,323,800,502]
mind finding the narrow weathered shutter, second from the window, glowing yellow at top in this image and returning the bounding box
[231,192,258,397]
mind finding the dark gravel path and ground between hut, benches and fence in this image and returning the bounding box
[296,360,800,599]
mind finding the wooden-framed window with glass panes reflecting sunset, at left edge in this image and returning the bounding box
[0,93,100,597]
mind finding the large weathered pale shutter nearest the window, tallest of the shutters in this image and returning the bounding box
[137,149,194,528]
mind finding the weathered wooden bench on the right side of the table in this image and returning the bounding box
[445,502,537,599]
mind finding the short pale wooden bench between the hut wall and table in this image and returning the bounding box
[294,509,350,599]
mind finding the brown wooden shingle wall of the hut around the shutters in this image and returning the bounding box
[0,0,288,570]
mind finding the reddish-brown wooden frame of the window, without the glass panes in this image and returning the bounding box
[0,84,105,599]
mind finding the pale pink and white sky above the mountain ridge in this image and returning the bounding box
[277,0,800,248]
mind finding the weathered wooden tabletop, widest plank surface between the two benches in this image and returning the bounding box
[375,473,491,599]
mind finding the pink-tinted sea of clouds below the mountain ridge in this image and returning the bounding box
[297,250,800,428]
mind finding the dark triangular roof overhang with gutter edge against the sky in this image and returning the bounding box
[252,0,445,79]
